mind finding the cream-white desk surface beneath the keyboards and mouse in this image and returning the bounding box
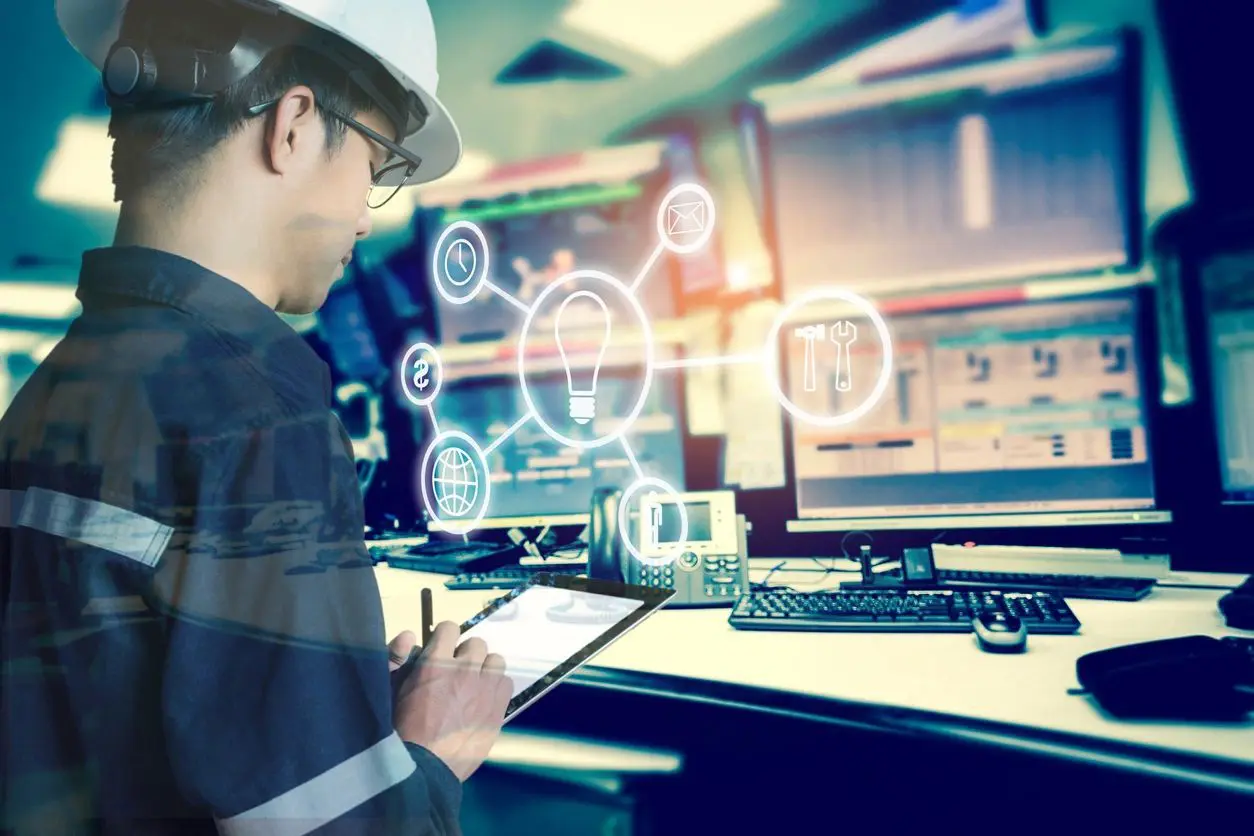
[377,562,1254,786]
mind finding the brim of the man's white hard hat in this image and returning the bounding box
[56,0,461,185]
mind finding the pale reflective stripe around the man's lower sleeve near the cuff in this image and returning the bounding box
[218,732,418,836]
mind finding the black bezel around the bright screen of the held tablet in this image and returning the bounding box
[461,572,675,722]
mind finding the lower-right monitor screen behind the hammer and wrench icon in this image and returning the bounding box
[781,288,1171,531]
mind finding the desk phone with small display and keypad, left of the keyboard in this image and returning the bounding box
[588,490,749,608]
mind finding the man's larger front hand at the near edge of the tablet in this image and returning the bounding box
[389,622,514,781]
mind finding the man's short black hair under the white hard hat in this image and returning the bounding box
[109,0,377,201]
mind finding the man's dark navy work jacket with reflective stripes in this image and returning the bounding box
[0,247,461,836]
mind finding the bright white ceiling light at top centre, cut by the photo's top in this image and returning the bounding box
[562,0,781,66]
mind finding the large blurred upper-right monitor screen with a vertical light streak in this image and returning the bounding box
[766,36,1140,298]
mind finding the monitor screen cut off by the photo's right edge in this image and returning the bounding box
[1203,252,1254,503]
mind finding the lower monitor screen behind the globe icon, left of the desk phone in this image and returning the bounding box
[436,368,685,528]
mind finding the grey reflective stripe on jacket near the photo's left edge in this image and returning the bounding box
[15,488,174,567]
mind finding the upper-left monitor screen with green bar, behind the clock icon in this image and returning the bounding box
[433,182,675,345]
